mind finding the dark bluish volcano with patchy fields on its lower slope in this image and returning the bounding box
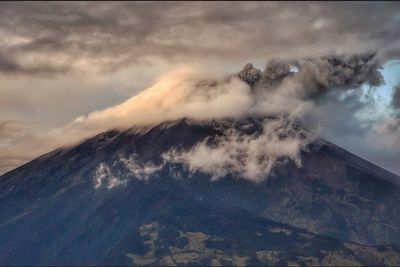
[0,117,400,266]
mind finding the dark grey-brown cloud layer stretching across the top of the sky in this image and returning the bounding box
[0,2,400,74]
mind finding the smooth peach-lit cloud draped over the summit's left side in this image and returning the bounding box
[62,67,253,140]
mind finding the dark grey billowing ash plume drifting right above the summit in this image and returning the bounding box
[238,53,383,99]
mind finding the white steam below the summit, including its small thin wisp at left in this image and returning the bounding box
[93,116,315,186]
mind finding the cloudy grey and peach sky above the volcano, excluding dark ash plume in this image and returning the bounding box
[0,2,400,176]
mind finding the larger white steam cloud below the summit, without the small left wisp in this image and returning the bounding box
[162,117,312,182]
